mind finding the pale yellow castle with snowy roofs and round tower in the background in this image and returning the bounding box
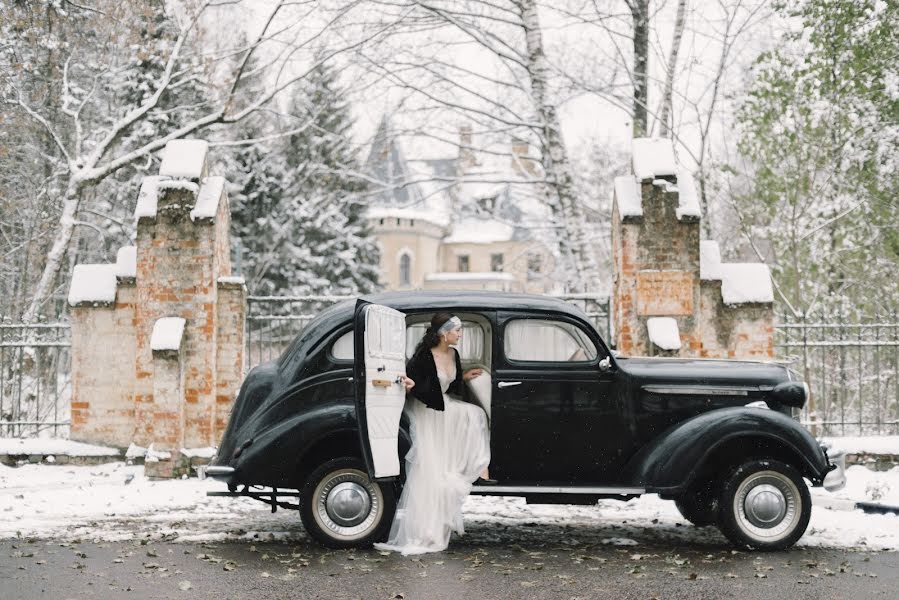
[366,117,563,293]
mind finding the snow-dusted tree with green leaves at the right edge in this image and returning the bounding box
[735,0,899,313]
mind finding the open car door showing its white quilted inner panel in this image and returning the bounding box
[353,300,406,479]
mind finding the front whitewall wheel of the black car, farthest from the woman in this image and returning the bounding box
[718,459,812,550]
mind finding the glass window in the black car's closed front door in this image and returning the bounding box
[503,319,596,362]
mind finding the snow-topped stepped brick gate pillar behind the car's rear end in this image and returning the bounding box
[70,142,246,472]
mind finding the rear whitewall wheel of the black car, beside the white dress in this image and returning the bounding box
[300,456,396,548]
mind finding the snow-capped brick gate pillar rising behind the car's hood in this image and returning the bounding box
[612,138,774,357]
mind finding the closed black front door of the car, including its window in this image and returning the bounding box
[490,312,632,484]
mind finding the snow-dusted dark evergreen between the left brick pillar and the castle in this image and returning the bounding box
[228,58,378,295]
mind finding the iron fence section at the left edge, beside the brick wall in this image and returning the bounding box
[0,323,71,437]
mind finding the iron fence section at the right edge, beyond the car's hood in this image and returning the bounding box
[775,316,899,435]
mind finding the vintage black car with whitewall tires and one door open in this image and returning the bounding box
[205,291,845,550]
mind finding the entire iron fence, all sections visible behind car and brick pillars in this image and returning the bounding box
[0,294,899,437]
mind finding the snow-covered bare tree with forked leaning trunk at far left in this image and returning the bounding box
[3,0,385,321]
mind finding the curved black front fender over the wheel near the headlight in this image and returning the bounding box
[624,406,831,495]
